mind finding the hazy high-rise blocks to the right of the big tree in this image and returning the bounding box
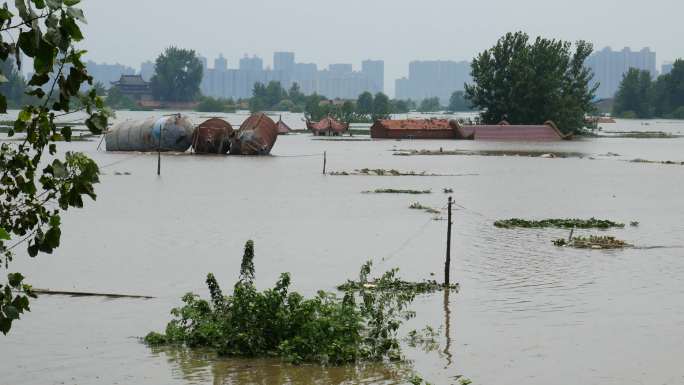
[586,47,656,99]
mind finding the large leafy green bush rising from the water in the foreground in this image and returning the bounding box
[144,241,415,364]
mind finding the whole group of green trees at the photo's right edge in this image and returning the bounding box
[613,59,684,119]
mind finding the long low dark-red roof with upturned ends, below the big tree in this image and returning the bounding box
[449,120,571,142]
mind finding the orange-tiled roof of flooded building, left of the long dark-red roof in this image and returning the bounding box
[371,119,456,139]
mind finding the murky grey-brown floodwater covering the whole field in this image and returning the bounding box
[0,112,684,385]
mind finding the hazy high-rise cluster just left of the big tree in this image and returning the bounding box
[395,60,470,105]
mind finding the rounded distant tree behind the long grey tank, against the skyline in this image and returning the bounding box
[151,47,202,102]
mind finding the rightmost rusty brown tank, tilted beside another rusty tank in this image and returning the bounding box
[230,113,278,155]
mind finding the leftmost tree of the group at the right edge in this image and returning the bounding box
[613,68,653,119]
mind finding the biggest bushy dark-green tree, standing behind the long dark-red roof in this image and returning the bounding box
[465,32,598,133]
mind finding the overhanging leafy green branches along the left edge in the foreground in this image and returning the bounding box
[0,0,110,334]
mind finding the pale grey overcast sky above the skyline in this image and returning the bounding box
[80,0,684,93]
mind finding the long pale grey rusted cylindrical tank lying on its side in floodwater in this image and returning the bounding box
[105,114,193,152]
